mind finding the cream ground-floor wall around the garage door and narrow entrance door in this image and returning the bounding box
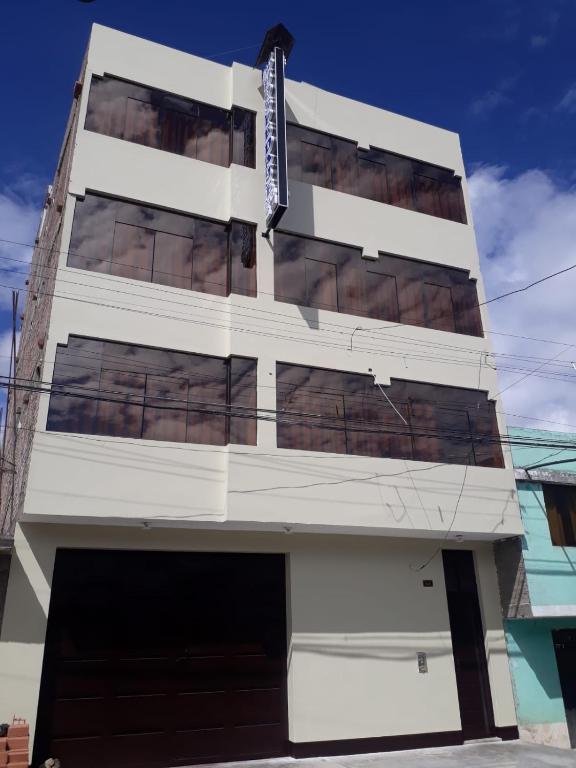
[0,524,515,742]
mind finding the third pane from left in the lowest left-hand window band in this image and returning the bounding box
[142,375,188,443]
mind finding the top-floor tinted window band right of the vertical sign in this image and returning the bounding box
[287,124,466,224]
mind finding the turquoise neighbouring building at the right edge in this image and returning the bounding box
[496,429,576,747]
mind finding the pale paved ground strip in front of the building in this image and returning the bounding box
[196,741,576,768]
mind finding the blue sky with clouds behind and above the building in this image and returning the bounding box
[0,0,576,426]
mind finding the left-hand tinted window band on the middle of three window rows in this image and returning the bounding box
[68,194,256,296]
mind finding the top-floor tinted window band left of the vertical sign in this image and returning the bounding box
[85,76,255,168]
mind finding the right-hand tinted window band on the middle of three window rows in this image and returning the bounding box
[274,232,482,336]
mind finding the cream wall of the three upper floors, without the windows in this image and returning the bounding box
[16,25,522,538]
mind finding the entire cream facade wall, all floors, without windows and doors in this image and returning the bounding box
[0,25,522,756]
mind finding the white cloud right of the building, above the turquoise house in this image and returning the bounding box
[470,166,576,432]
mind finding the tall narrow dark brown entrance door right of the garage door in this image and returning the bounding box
[442,550,495,739]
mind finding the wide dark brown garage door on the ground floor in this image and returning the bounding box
[34,550,287,768]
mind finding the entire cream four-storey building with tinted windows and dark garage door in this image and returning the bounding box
[0,26,522,768]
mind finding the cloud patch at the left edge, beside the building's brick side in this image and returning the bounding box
[0,176,42,309]
